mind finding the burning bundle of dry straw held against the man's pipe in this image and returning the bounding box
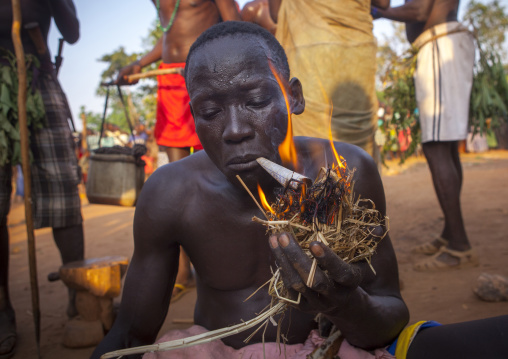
[253,158,389,304]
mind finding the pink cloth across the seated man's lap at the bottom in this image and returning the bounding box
[143,325,395,359]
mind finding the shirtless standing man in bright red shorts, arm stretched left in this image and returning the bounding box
[117,0,240,300]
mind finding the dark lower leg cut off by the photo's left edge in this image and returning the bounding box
[0,224,16,358]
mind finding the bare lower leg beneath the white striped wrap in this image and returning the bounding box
[422,142,471,251]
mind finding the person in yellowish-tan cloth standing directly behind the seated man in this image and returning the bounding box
[269,0,390,162]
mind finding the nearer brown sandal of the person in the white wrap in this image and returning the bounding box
[414,246,478,272]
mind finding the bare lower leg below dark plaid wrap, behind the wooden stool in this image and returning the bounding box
[53,224,85,318]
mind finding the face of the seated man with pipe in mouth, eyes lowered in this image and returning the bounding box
[187,35,300,185]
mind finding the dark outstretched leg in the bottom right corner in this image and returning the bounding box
[407,315,508,359]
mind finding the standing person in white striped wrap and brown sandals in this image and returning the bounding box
[373,0,478,271]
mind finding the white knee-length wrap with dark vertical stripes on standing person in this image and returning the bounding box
[413,22,475,143]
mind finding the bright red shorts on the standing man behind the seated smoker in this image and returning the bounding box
[154,63,203,150]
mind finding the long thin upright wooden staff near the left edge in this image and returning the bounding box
[12,0,41,358]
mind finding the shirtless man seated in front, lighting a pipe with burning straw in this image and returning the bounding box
[93,22,408,358]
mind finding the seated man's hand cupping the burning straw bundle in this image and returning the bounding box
[270,232,382,316]
